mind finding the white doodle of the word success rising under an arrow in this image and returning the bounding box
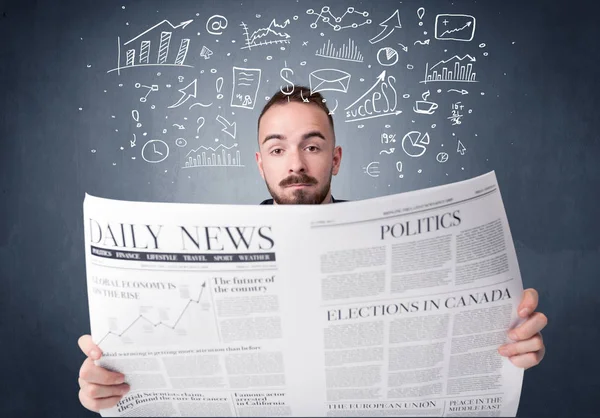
[345,71,402,122]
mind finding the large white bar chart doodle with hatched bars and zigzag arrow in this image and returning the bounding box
[107,19,193,75]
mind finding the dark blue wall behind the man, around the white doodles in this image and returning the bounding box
[0,0,600,417]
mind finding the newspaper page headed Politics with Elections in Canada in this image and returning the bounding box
[297,172,523,416]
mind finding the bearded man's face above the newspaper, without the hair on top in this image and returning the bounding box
[256,102,342,204]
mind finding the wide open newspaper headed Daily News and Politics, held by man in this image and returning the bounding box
[84,172,523,417]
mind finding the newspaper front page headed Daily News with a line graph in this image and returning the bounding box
[84,195,297,416]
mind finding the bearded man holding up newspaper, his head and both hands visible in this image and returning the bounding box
[79,87,547,411]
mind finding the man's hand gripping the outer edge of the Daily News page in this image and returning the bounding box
[78,335,129,412]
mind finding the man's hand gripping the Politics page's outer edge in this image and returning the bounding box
[498,289,548,370]
